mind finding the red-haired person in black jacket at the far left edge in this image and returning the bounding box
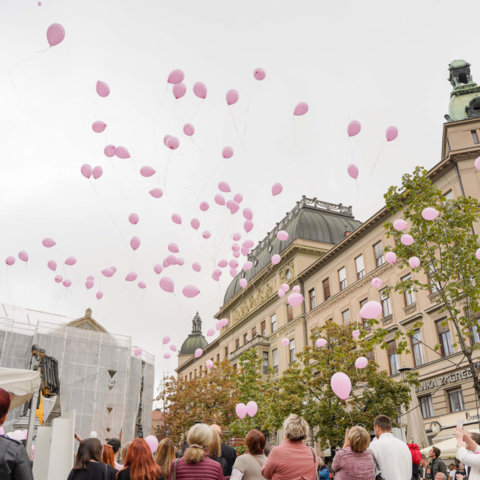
[0,388,33,480]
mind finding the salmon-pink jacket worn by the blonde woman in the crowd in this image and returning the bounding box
[262,440,318,480]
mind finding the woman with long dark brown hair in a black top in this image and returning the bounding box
[67,438,115,480]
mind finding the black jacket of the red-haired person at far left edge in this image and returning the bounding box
[0,436,33,480]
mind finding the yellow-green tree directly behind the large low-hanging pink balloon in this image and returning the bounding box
[270,320,417,448]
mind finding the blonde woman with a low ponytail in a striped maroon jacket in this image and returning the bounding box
[168,423,224,480]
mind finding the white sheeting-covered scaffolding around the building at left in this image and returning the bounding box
[0,317,154,442]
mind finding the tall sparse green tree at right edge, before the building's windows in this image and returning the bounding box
[382,167,480,397]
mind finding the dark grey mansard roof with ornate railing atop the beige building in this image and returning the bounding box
[223,196,362,304]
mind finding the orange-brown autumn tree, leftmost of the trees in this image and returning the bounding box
[157,361,238,442]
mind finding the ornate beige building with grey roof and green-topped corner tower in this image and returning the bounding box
[177,60,480,442]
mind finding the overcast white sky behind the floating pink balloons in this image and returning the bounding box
[0,0,480,384]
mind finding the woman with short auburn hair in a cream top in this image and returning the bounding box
[230,429,267,480]
